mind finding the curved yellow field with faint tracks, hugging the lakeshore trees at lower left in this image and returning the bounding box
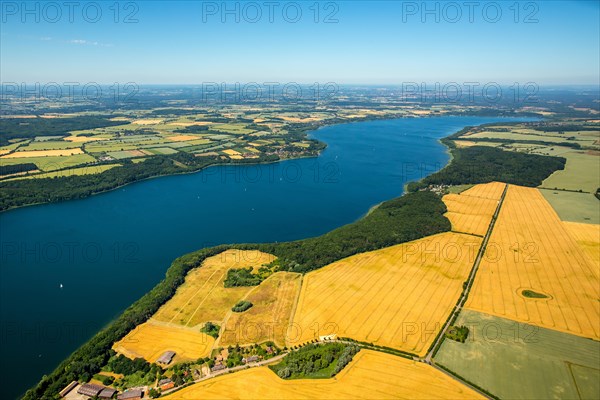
[154,250,275,327]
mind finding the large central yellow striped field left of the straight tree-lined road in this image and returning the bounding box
[288,232,481,355]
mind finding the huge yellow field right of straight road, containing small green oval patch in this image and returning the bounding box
[467,186,600,339]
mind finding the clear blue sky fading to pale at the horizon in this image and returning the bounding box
[0,0,600,85]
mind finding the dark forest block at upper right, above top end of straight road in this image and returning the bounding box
[408,146,566,192]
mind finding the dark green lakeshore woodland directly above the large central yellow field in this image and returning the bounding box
[248,191,451,273]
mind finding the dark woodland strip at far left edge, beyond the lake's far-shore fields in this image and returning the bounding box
[0,116,123,146]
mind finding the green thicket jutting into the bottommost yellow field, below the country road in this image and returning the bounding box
[269,343,360,379]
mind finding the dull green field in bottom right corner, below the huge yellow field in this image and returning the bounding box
[435,310,600,399]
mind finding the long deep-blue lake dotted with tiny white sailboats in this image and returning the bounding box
[0,117,528,398]
